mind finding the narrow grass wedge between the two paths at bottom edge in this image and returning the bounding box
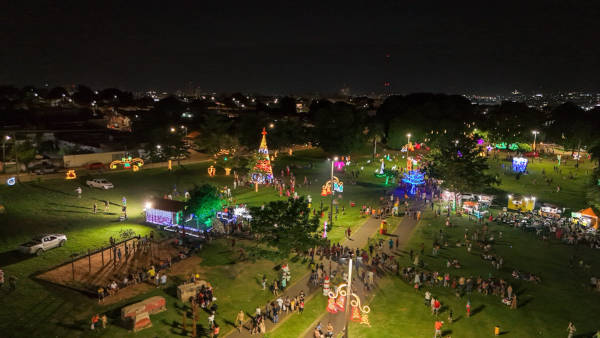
[264,293,327,338]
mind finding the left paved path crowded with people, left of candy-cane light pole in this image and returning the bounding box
[226,217,392,338]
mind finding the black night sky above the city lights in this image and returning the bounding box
[0,0,600,94]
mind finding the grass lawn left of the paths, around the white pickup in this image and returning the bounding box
[0,151,390,336]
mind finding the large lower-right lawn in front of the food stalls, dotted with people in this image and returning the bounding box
[351,207,600,337]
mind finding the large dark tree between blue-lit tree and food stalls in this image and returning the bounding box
[427,134,499,197]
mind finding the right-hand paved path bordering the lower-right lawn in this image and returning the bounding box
[301,201,424,338]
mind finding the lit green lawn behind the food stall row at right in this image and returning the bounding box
[488,155,594,211]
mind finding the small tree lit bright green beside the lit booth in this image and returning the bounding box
[185,184,223,224]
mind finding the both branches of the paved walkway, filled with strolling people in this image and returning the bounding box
[227,199,420,338]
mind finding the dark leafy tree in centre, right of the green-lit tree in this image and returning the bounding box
[250,197,322,257]
